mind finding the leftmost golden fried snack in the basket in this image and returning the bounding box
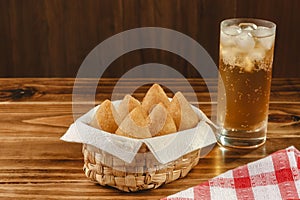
[90,100,119,133]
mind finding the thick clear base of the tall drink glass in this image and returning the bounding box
[217,126,267,149]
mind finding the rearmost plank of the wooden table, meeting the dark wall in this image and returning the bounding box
[0,78,300,104]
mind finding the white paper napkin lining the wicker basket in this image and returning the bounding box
[61,101,216,164]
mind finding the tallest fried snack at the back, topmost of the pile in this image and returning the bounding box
[142,84,170,113]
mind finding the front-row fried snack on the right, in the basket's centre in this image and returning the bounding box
[149,103,177,137]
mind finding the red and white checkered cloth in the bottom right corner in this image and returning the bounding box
[164,146,300,200]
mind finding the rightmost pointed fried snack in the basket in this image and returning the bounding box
[168,92,199,131]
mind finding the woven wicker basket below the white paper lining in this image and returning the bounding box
[82,144,200,192]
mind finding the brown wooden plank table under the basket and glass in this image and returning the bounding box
[0,78,300,199]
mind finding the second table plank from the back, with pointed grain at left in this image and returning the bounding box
[0,103,300,138]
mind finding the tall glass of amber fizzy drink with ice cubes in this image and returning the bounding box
[217,19,276,148]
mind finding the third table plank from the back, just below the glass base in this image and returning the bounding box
[0,137,300,160]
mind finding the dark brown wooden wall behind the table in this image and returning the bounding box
[0,0,300,77]
